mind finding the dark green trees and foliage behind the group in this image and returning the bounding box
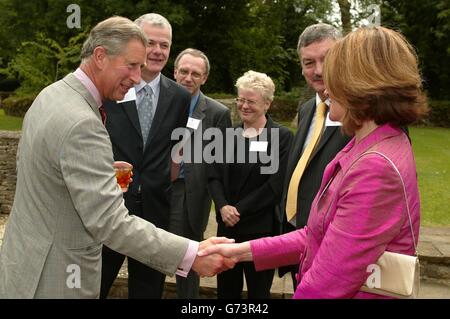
[0,0,450,99]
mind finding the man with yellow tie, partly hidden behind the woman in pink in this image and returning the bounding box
[279,23,350,290]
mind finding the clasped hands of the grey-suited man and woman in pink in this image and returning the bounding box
[192,237,253,277]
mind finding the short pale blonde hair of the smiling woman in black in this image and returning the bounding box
[235,70,275,102]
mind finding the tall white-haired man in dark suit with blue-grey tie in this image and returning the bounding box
[101,13,191,299]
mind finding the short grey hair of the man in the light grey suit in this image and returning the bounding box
[80,16,148,62]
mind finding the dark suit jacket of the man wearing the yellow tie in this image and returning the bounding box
[280,97,351,231]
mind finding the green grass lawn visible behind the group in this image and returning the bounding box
[0,109,450,226]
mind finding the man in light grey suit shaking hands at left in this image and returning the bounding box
[0,17,232,298]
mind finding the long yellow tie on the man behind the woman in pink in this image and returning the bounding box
[286,102,327,221]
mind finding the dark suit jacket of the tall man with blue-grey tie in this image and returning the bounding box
[105,75,191,229]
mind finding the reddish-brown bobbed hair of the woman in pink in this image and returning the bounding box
[323,27,428,134]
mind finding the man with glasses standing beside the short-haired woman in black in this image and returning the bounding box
[169,48,231,299]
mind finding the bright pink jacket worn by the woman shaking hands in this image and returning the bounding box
[250,124,420,298]
